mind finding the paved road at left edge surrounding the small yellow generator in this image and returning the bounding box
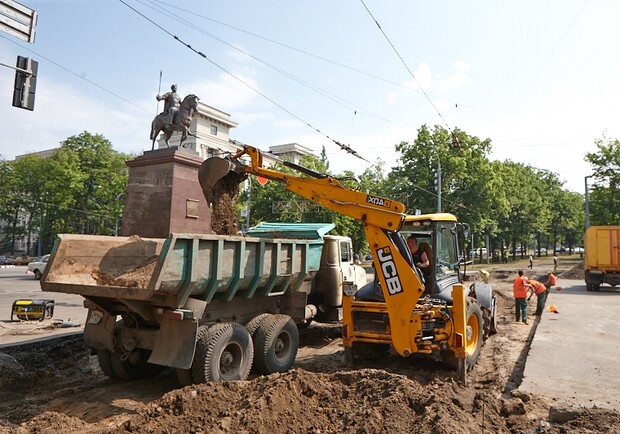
[0,267,87,346]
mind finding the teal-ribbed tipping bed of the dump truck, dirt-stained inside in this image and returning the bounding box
[41,234,323,308]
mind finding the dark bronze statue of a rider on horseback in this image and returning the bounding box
[151,84,198,151]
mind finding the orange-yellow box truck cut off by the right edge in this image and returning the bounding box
[584,226,620,291]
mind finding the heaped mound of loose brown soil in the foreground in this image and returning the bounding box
[114,369,501,434]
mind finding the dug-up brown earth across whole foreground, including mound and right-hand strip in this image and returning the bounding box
[0,260,620,434]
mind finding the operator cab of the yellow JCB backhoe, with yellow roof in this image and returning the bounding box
[400,213,461,302]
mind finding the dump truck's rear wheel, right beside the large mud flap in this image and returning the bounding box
[192,323,254,383]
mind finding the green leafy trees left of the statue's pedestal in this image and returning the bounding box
[0,132,130,254]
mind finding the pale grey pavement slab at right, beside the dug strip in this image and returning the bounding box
[519,279,620,410]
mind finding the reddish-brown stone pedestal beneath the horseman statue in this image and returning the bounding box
[120,147,213,238]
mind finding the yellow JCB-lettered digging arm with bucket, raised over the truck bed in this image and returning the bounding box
[198,146,424,356]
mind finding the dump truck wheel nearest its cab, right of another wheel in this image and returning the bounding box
[254,314,299,375]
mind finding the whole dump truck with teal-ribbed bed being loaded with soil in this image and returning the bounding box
[41,223,366,385]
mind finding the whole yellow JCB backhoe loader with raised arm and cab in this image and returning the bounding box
[198,146,495,383]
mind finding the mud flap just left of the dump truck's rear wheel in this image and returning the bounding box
[148,317,198,369]
